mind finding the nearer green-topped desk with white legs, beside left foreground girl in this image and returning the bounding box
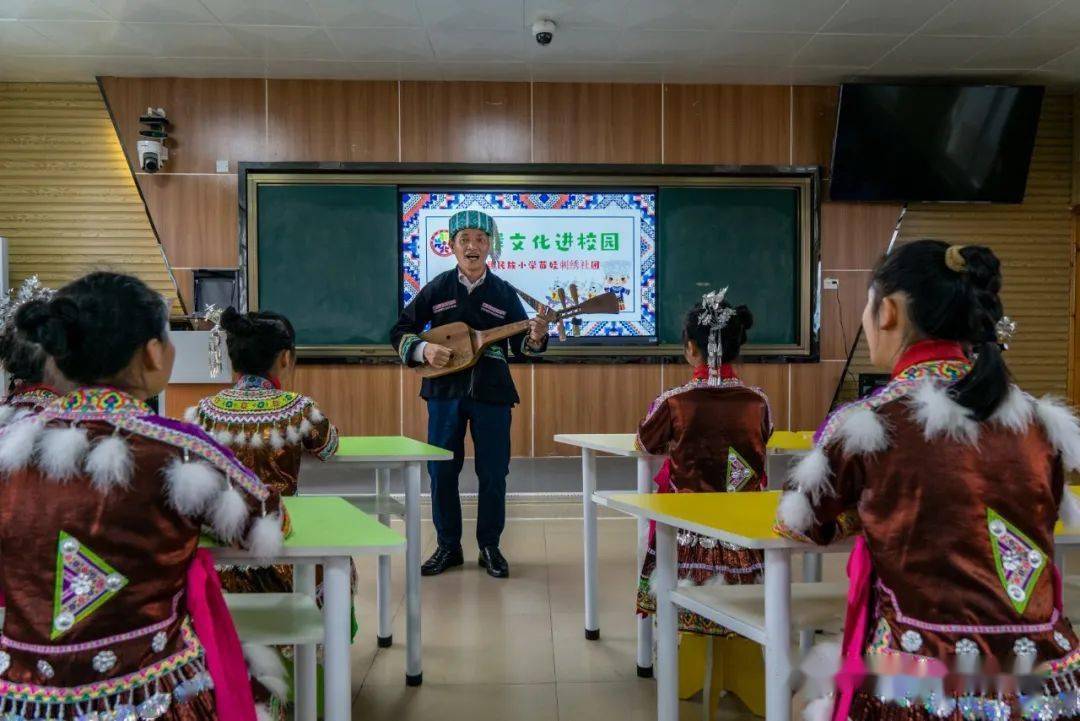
[202,496,405,721]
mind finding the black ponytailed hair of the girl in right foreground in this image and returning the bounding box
[870,240,1011,421]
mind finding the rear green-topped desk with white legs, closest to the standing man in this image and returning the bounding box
[319,436,454,685]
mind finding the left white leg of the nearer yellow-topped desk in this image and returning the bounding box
[652,523,673,721]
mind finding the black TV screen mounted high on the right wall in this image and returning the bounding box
[829,84,1043,203]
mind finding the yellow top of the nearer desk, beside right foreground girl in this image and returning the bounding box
[593,486,1080,550]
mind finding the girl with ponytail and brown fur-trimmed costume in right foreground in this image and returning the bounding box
[778,240,1080,721]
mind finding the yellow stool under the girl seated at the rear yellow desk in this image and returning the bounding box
[678,634,765,719]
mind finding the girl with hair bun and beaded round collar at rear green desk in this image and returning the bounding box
[187,308,338,593]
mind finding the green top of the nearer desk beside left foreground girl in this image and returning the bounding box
[200,495,405,559]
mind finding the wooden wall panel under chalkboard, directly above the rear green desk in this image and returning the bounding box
[289,364,402,436]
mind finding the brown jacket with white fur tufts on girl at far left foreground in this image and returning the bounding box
[0,389,282,721]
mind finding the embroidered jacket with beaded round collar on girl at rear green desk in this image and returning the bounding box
[186,376,338,495]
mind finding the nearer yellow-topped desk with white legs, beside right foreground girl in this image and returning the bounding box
[594,491,1080,721]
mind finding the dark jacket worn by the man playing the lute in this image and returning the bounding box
[390,269,548,405]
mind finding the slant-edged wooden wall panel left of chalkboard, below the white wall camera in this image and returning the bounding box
[137,173,240,268]
